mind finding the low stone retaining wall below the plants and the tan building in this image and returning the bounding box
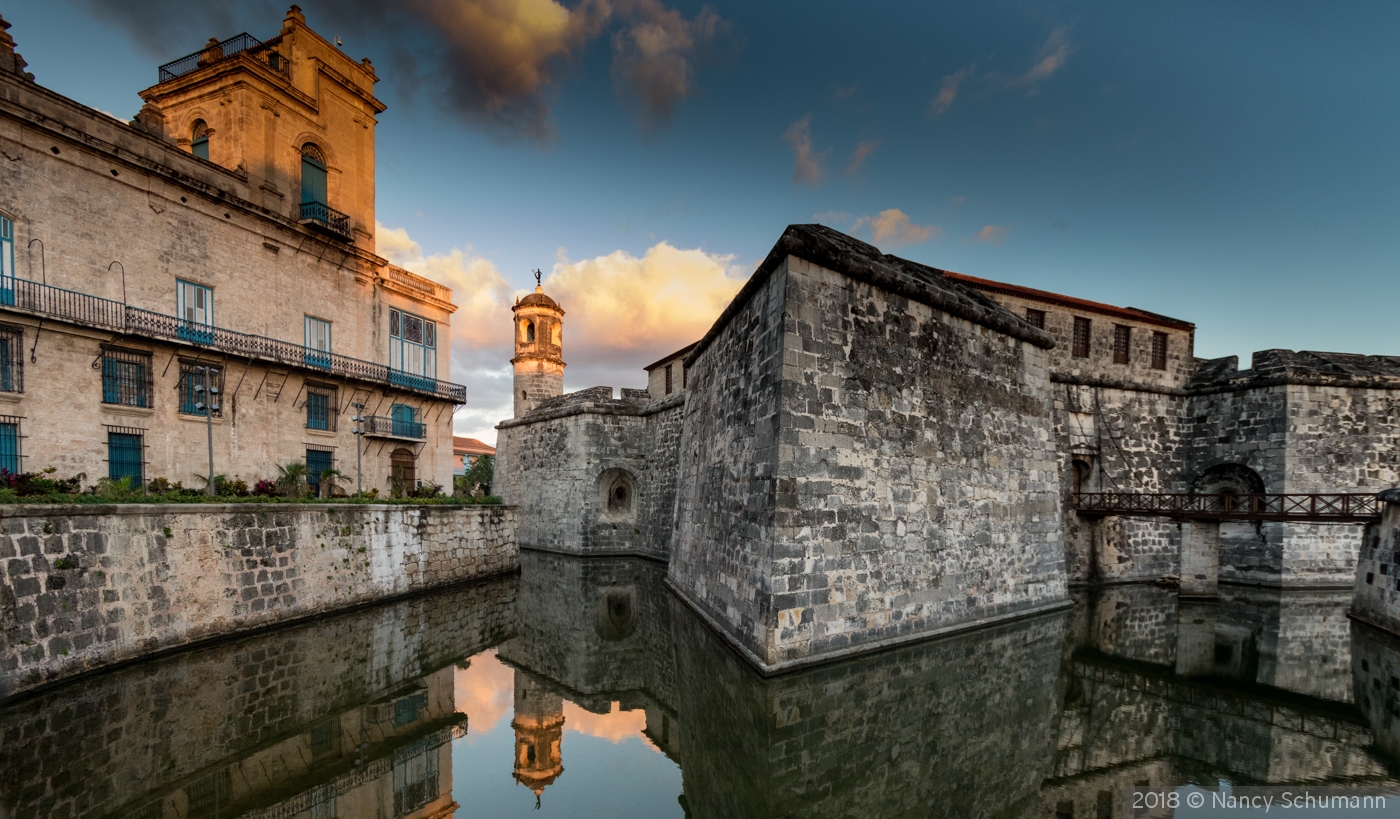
[0,504,519,696]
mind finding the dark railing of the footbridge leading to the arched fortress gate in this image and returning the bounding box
[1074,491,1380,522]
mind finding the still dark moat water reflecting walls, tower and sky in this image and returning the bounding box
[0,553,1400,819]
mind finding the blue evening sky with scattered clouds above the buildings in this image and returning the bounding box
[4,0,1400,442]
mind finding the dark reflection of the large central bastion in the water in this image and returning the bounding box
[672,593,1064,819]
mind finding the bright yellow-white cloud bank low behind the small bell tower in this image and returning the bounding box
[375,224,748,442]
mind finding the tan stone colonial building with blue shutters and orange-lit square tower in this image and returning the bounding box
[0,6,465,490]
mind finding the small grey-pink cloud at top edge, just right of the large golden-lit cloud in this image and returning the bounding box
[612,0,731,129]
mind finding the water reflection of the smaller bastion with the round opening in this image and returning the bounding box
[498,552,676,714]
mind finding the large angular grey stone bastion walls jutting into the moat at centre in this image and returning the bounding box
[671,255,1065,666]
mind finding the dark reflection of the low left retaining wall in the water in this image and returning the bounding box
[0,577,517,816]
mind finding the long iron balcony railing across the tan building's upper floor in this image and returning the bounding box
[0,279,466,403]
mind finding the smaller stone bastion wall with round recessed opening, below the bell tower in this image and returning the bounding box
[491,386,685,560]
